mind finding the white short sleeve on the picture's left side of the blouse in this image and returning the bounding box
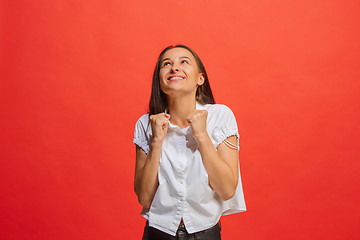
[133,114,151,154]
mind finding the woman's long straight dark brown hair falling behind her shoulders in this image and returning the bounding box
[149,45,215,116]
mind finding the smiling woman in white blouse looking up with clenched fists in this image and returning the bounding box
[133,45,246,240]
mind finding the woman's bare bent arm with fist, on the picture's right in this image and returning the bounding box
[188,110,239,201]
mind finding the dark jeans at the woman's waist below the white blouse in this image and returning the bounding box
[142,222,221,240]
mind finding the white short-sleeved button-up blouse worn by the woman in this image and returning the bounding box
[133,103,246,236]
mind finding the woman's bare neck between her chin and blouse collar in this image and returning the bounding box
[168,96,196,128]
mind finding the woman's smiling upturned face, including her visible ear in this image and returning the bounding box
[159,47,204,96]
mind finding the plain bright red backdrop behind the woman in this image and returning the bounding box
[0,0,360,240]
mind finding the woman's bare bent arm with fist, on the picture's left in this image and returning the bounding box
[134,113,170,208]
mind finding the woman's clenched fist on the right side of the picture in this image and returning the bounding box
[187,110,208,142]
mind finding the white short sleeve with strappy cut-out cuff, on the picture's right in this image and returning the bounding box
[212,105,240,149]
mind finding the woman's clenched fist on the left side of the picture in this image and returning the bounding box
[150,113,170,143]
